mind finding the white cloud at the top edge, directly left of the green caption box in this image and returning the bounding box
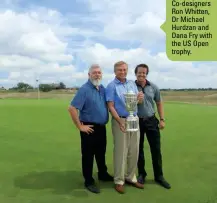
[85,0,165,46]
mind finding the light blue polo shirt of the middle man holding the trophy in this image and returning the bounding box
[106,78,138,117]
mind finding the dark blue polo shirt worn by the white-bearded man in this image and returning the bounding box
[71,80,109,124]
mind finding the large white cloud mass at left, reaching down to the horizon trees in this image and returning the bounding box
[0,9,83,86]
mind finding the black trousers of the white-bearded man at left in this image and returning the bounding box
[80,122,107,185]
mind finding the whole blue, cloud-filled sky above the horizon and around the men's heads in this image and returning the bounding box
[0,0,217,88]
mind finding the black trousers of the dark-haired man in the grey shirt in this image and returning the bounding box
[138,116,163,179]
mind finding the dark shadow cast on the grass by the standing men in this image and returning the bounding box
[14,171,112,197]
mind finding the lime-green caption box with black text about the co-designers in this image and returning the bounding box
[161,0,217,61]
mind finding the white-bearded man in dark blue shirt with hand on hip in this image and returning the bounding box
[69,65,113,193]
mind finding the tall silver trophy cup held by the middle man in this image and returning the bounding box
[124,90,139,132]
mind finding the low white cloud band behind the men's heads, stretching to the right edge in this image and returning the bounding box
[80,44,217,88]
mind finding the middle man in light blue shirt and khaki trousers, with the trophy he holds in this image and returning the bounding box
[106,61,144,193]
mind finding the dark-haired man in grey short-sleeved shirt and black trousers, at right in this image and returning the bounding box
[135,64,171,189]
